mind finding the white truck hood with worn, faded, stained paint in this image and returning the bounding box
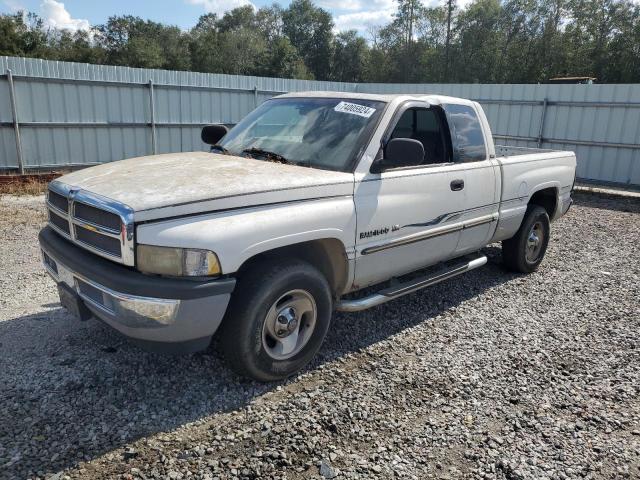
[59,152,353,221]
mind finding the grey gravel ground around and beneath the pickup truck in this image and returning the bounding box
[0,194,640,479]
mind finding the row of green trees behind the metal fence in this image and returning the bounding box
[0,0,640,83]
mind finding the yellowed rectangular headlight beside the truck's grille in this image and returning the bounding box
[136,245,222,277]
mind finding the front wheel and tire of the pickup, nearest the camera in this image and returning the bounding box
[219,259,333,381]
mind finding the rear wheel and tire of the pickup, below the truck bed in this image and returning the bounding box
[502,205,551,273]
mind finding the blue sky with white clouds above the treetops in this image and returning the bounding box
[0,0,470,34]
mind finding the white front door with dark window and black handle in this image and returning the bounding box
[354,101,467,288]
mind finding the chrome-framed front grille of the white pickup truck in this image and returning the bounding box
[47,181,134,265]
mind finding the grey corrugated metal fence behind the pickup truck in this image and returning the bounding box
[0,57,640,186]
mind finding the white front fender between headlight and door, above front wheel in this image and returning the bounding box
[136,196,356,274]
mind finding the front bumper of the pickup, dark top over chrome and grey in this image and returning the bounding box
[39,227,235,353]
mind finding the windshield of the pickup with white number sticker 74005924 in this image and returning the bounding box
[219,98,385,172]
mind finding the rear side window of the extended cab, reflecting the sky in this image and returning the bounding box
[443,104,487,162]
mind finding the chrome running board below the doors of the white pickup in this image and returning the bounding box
[336,255,487,312]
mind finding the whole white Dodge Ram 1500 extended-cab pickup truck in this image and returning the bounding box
[40,92,576,381]
